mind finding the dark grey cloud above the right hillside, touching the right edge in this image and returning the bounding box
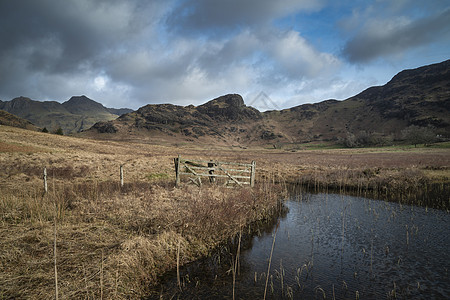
[343,9,450,63]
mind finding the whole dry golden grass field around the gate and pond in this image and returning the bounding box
[0,126,450,299]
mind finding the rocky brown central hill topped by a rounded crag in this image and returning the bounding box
[83,94,265,145]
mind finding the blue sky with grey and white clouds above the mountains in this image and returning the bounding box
[0,0,450,110]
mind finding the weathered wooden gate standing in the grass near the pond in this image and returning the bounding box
[174,155,256,187]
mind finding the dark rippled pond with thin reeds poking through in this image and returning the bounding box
[149,194,450,299]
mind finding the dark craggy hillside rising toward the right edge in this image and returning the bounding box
[264,60,450,142]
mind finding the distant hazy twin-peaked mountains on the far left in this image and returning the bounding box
[0,96,131,134]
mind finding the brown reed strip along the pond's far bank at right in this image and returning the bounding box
[295,168,450,209]
